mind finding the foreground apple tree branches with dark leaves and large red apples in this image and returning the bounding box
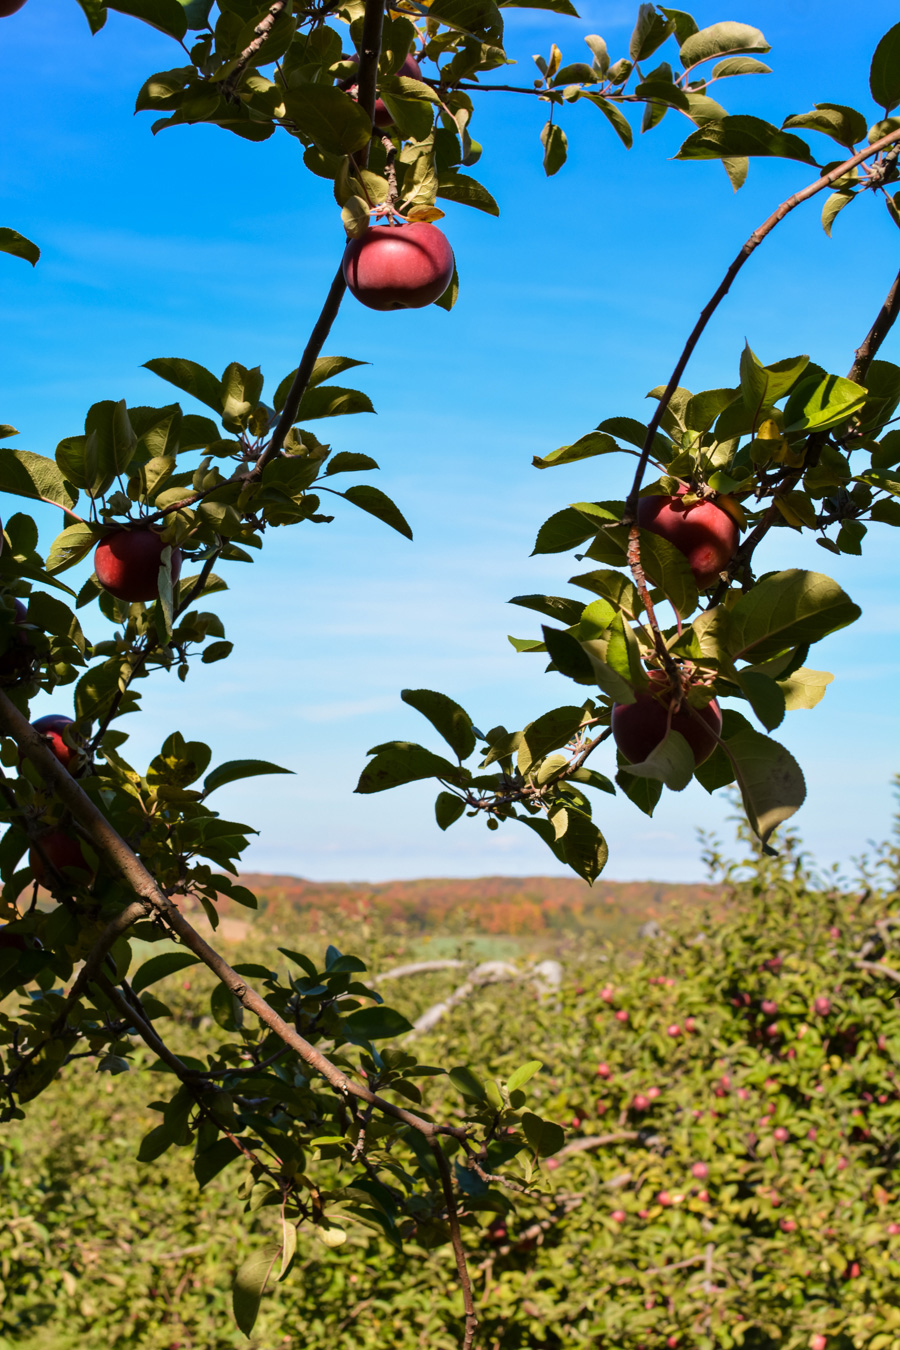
[0,0,900,1346]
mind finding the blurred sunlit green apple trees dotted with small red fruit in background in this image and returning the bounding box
[0,804,900,1350]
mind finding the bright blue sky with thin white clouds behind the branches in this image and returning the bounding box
[0,0,900,880]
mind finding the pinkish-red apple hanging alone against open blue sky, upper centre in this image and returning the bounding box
[343,220,453,309]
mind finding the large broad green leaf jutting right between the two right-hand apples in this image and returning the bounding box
[729,568,861,663]
